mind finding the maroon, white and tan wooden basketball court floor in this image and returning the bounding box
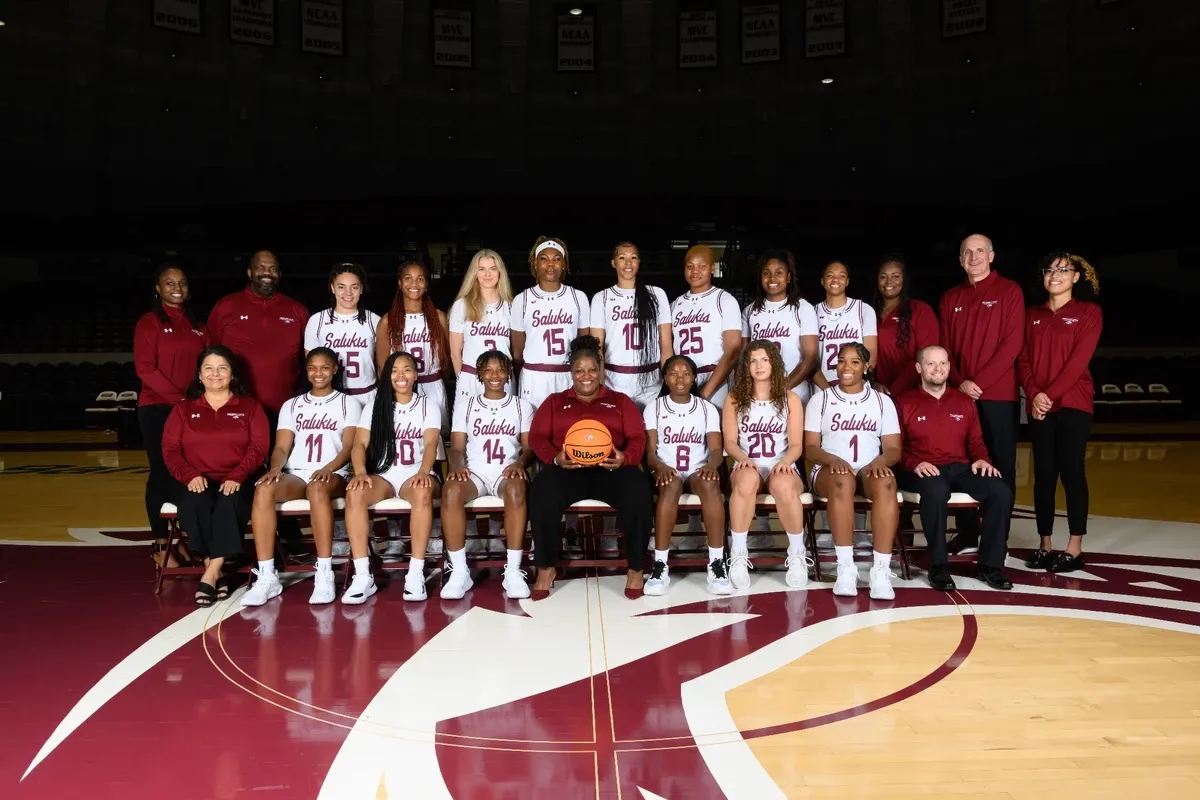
[0,434,1200,800]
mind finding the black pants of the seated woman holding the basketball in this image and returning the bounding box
[528,464,654,570]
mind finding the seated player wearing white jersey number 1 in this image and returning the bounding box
[804,342,900,600]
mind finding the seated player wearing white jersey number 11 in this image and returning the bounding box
[241,347,361,606]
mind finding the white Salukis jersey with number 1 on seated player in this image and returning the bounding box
[804,384,900,473]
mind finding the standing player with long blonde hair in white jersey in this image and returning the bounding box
[449,248,514,401]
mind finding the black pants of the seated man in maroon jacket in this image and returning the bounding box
[896,464,1013,567]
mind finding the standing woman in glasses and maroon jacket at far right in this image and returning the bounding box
[1016,252,1103,572]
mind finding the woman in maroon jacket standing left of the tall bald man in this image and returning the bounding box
[871,255,938,397]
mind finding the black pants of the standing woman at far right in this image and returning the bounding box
[1030,408,1092,536]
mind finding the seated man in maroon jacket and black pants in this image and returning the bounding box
[896,344,1013,591]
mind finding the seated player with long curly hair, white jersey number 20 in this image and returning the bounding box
[721,339,809,589]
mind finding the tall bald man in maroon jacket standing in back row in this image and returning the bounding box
[938,234,1025,553]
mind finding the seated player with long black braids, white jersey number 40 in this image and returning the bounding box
[342,351,442,604]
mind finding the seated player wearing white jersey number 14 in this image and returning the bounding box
[442,350,534,600]
